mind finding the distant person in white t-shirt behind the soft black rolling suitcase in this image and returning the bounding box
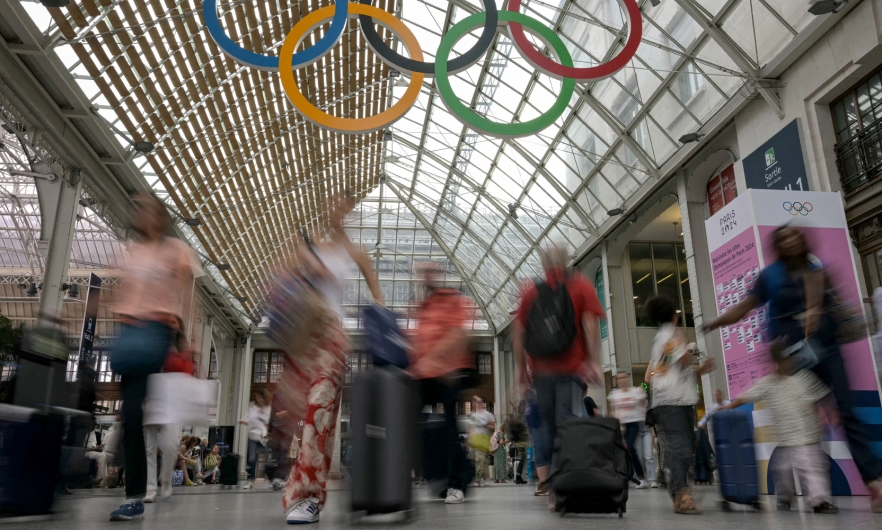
[608,373,658,489]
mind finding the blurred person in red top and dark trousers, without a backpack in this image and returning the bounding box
[408,262,477,504]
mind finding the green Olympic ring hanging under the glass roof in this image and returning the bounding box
[435,11,576,138]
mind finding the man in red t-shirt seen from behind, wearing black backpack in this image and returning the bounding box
[514,247,604,495]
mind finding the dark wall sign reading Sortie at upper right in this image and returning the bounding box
[743,120,810,191]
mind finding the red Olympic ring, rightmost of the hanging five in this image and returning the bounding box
[508,0,643,81]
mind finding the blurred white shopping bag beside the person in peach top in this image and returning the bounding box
[144,372,217,426]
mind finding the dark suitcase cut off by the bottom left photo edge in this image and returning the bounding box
[0,405,64,516]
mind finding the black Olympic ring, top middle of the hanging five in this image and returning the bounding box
[358,0,499,76]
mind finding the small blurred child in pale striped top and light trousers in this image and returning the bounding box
[720,338,839,514]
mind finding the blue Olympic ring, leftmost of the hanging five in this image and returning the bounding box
[202,0,349,72]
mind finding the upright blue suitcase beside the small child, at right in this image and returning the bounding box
[713,410,762,511]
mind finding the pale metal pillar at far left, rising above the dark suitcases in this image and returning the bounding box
[34,172,83,318]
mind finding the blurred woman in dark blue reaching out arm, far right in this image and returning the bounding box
[702,225,882,512]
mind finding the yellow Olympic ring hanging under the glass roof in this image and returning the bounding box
[279,3,425,134]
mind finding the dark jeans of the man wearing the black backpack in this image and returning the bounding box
[533,375,584,467]
